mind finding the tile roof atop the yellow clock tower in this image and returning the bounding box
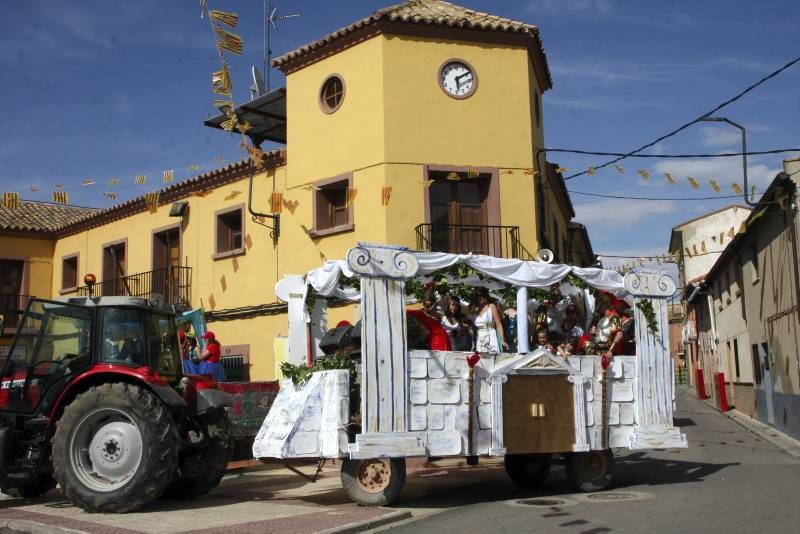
[272,0,552,87]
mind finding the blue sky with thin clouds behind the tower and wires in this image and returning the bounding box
[0,0,800,268]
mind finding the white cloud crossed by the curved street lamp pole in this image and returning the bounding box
[653,157,781,194]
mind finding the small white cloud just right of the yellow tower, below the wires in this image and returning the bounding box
[575,199,678,228]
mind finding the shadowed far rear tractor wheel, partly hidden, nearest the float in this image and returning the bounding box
[161,408,233,499]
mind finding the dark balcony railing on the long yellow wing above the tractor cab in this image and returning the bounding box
[68,267,192,309]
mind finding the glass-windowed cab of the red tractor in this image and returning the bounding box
[0,297,181,415]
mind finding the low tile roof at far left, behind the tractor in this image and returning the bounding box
[0,200,100,233]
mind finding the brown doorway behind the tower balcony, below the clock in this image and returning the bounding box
[428,169,502,254]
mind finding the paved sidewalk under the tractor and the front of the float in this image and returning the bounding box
[0,459,505,534]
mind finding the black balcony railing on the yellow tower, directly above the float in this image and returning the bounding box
[416,223,533,260]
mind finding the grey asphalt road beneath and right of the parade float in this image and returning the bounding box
[384,390,800,534]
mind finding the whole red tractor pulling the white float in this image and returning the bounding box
[0,282,233,512]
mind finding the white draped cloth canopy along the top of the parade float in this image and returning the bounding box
[306,252,626,300]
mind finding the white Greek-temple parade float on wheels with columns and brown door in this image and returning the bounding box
[253,244,687,505]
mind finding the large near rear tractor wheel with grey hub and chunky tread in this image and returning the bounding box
[53,383,178,513]
